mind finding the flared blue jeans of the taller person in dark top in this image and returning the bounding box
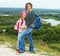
[17,27,34,51]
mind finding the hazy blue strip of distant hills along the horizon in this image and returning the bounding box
[0,7,60,13]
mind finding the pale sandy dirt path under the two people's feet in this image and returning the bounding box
[0,44,52,56]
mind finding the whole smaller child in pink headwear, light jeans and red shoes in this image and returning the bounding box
[16,11,27,53]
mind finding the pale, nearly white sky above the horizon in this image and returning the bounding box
[0,0,60,9]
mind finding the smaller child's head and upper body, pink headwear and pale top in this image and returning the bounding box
[18,11,26,32]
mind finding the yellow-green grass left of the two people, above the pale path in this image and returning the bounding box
[0,33,17,44]
